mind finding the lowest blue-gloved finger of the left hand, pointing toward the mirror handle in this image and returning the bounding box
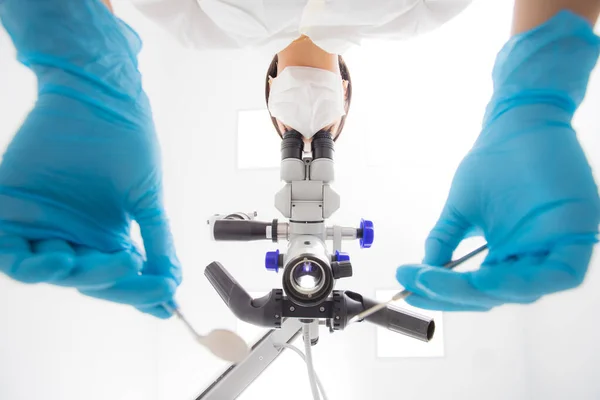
[79,275,177,308]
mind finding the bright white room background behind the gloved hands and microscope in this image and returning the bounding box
[0,0,600,400]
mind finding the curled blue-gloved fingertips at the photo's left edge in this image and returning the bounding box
[0,233,75,284]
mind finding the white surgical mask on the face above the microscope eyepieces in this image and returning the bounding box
[268,67,346,139]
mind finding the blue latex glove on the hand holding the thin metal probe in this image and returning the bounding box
[396,8,600,311]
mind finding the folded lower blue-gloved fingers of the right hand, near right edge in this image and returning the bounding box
[471,244,593,303]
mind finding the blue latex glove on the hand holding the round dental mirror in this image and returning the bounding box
[0,0,181,318]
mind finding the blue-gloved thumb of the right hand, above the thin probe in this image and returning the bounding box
[423,206,474,267]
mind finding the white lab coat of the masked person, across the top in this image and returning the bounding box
[131,0,472,54]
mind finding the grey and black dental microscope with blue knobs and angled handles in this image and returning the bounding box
[198,131,435,400]
